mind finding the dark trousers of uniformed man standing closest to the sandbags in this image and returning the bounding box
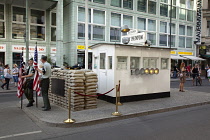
[41,78,51,109]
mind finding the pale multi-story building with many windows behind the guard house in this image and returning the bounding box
[0,0,196,68]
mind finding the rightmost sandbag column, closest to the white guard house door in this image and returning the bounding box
[85,72,98,109]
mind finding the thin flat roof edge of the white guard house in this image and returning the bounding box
[90,43,177,50]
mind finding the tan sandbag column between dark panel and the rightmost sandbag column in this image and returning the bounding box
[66,70,85,111]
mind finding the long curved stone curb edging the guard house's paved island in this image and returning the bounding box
[23,101,210,128]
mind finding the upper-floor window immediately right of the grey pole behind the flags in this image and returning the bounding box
[30,9,45,41]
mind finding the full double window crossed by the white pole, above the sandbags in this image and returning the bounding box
[78,7,105,41]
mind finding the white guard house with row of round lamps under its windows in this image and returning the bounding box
[91,43,174,103]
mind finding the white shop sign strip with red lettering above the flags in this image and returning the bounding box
[12,45,46,52]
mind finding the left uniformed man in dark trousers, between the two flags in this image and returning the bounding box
[22,58,35,107]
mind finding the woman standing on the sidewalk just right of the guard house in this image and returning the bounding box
[179,62,186,92]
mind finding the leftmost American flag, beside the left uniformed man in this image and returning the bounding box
[17,51,24,98]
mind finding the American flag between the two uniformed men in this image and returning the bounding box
[33,45,41,96]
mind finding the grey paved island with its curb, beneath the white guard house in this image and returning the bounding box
[19,89,210,127]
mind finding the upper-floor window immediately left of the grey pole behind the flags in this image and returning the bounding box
[12,7,26,39]
